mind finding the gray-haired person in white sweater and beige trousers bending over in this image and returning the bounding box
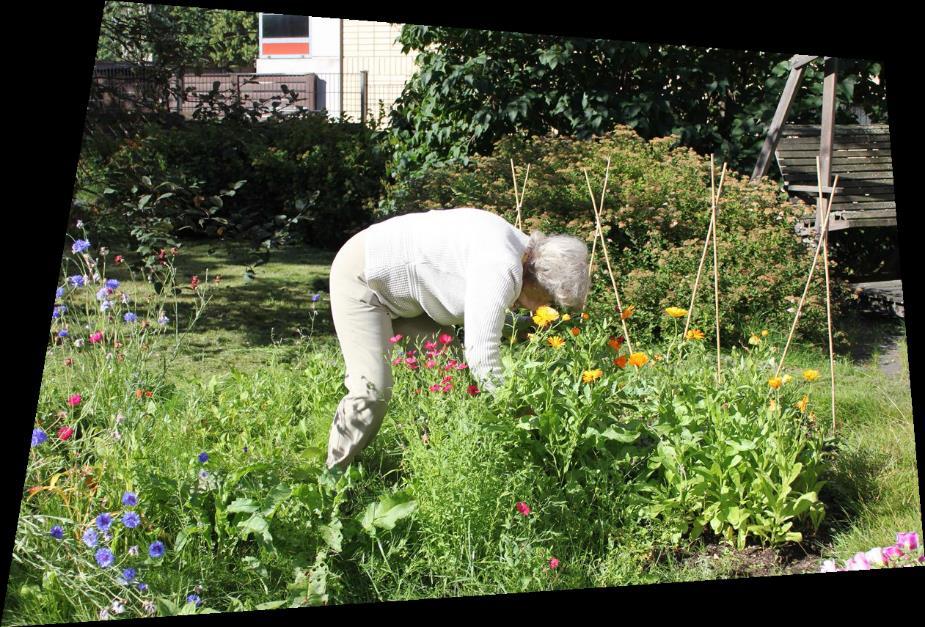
[327,208,589,472]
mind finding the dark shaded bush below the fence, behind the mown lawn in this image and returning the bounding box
[77,107,385,270]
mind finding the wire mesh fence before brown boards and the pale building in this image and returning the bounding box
[91,64,405,125]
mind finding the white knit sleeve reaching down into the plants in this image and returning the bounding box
[463,267,520,391]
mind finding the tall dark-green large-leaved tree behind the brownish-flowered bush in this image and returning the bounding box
[391,25,886,186]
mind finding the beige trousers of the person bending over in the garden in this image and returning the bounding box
[327,231,455,470]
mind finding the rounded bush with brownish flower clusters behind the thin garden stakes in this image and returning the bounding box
[389,127,847,344]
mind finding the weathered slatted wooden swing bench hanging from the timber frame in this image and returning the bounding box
[775,124,896,232]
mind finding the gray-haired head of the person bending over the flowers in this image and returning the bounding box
[524,231,591,309]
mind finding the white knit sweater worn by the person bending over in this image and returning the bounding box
[366,208,529,390]
